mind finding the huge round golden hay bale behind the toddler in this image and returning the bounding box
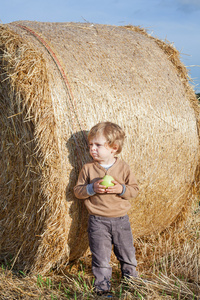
[0,21,199,273]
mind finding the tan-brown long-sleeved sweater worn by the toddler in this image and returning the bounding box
[74,158,139,218]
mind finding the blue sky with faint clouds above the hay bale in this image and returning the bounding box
[0,0,200,92]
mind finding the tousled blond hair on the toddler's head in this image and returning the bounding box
[88,122,125,154]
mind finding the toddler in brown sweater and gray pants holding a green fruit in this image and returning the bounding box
[74,122,139,294]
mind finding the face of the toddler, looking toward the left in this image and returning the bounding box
[89,134,117,164]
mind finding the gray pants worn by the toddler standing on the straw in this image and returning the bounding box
[88,215,137,291]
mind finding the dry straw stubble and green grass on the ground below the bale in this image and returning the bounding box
[0,201,200,300]
